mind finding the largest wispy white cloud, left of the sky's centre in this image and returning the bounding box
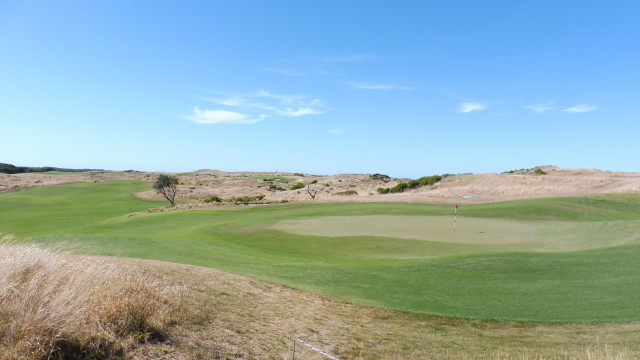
[186,89,327,124]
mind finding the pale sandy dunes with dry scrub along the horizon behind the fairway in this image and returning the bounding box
[0,166,640,207]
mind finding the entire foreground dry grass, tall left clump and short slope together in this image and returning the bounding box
[0,245,640,360]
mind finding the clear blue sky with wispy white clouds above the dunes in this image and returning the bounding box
[0,0,640,178]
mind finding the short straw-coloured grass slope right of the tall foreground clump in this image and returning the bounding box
[126,259,640,360]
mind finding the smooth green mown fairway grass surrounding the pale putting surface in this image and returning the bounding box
[0,182,640,322]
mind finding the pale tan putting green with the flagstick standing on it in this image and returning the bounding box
[273,215,640,251]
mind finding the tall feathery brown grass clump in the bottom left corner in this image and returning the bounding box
[0,244,177,360]
